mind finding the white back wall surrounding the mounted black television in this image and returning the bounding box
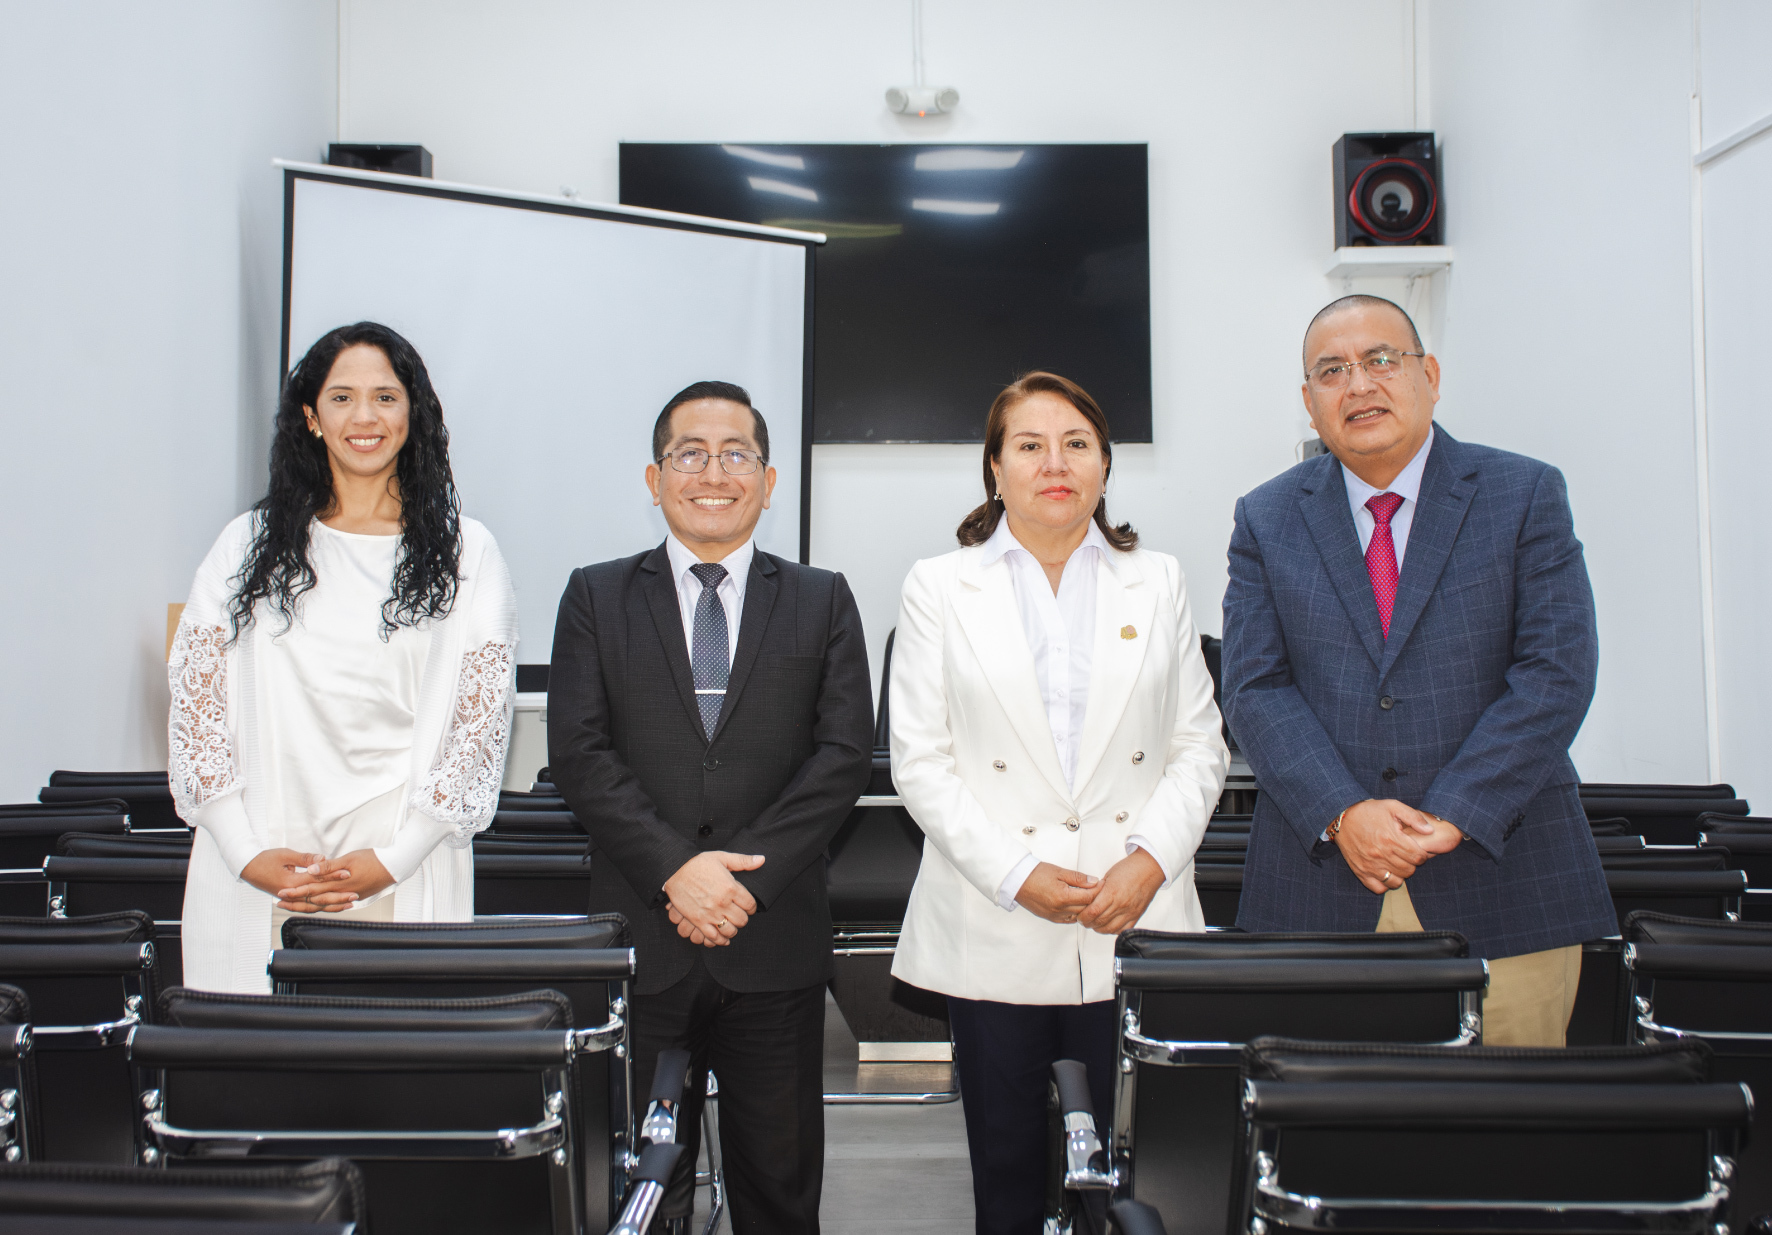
[344,0,1414,683]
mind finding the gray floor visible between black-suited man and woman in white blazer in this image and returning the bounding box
[696,998,973,1235]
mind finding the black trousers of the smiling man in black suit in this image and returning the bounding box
[629,960,824,1235]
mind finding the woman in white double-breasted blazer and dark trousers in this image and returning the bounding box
[891,372,1228,1235]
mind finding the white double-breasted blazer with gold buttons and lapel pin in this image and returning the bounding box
[891,548,1230,1005]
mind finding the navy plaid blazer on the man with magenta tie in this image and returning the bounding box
[1224,429,1618,959]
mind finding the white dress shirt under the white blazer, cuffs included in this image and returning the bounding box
[982,517,1173,913]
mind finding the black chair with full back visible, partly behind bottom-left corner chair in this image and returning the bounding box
[129,992,585,1235]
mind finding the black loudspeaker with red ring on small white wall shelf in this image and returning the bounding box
[1334,133,1446,248]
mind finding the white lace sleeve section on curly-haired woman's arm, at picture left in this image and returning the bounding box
[167,617,239,820]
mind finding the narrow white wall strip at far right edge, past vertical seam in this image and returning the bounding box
[1699,0,1772,815]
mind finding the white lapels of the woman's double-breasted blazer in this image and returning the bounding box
[953,546,1157,803]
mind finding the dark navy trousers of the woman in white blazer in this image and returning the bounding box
[948,996,1115,1235]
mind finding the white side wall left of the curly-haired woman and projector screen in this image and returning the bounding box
[0,0,337,801]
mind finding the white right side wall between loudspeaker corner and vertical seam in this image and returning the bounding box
[1428,0,1715,779]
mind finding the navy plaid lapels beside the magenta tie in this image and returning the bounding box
[1299,425,1478,682]
